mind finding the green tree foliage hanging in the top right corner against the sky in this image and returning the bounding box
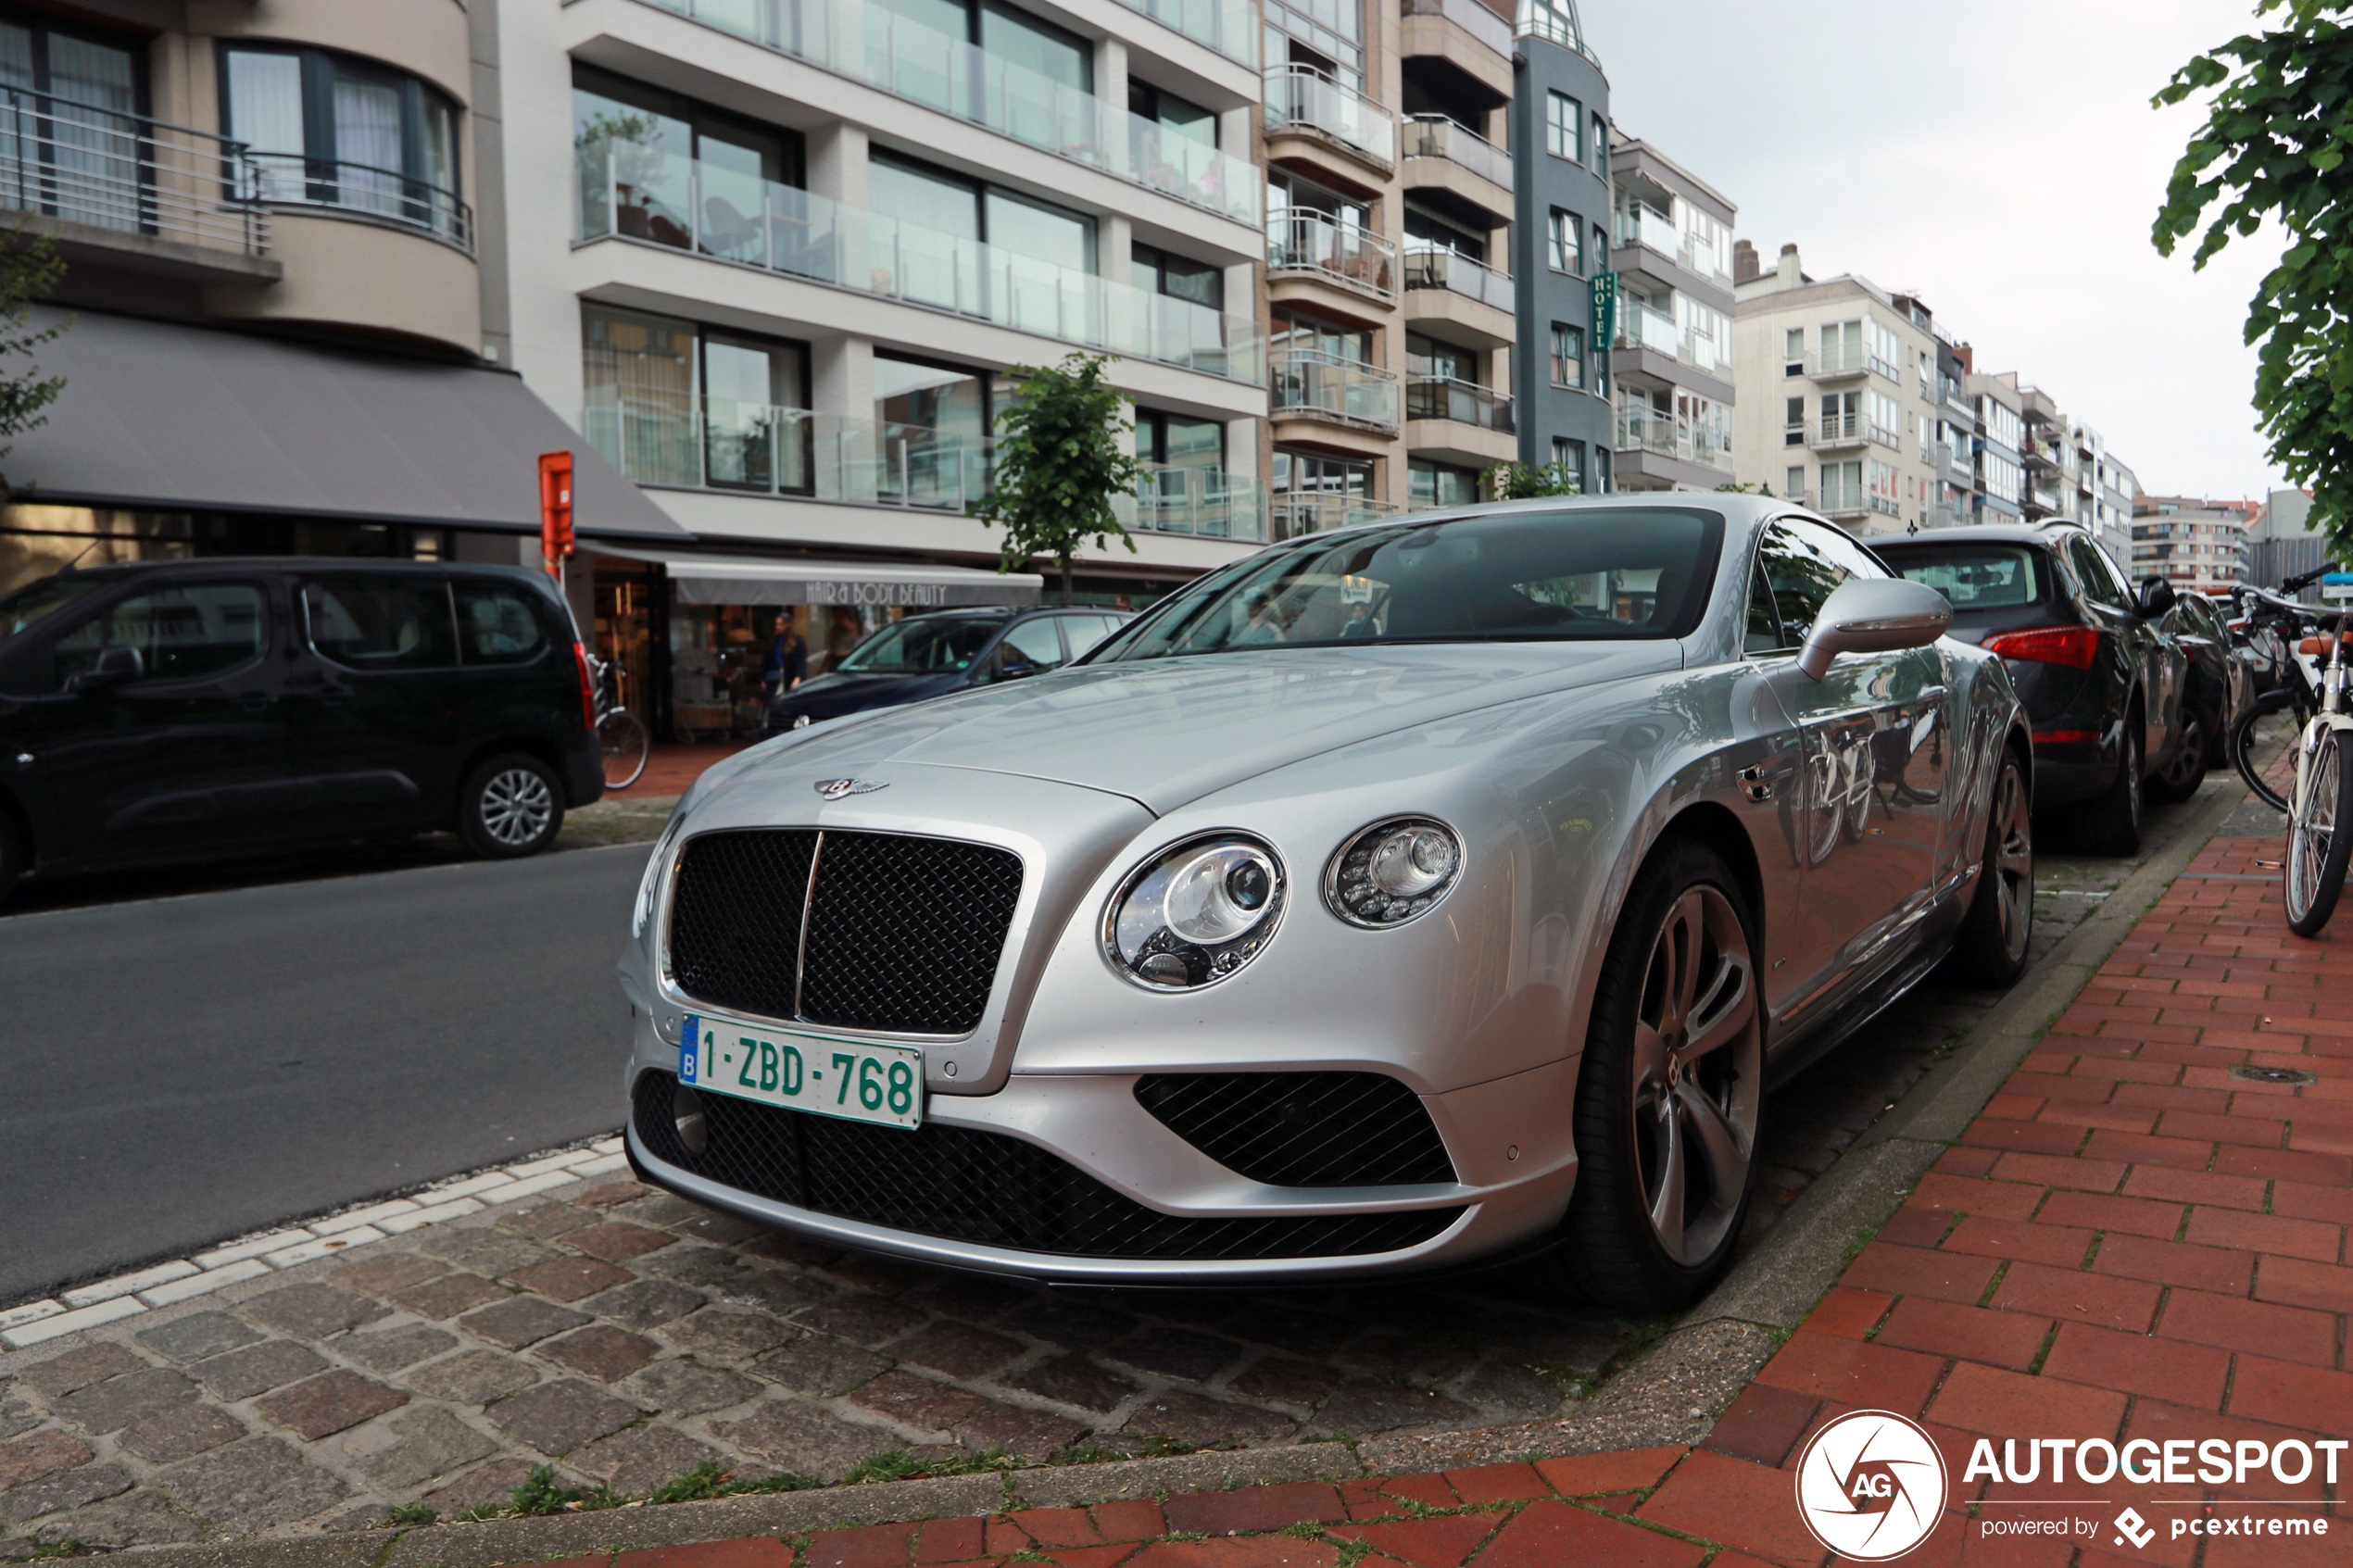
[2153,0,2353,562]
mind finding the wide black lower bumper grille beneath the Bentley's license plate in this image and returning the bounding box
[635,1072,1464,1260]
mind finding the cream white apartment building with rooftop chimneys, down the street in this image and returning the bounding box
[1731,245,1957,533]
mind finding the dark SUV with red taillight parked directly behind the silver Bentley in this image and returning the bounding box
[1870,524,2200,856]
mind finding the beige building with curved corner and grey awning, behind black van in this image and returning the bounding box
[0,0,687,590]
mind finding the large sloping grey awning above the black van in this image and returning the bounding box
[7,308,687,538]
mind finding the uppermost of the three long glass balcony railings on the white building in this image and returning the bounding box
[621,0,1266,226]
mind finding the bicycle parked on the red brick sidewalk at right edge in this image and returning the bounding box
[2231,571,2353,935]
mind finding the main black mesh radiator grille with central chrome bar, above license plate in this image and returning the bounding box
[671,827,1021,1035]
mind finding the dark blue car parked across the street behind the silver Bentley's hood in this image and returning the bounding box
[767,608,1134,735]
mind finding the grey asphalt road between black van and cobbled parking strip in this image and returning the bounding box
[0,844,645,1302]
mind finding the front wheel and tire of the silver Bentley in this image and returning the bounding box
[1553,839,1765,1314]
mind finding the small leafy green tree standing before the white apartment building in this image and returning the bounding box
[972,353,1149,604]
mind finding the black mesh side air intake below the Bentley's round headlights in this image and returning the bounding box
[1137,1072,1454,1187]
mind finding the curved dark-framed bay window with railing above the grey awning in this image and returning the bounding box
[221,44,473,245]
